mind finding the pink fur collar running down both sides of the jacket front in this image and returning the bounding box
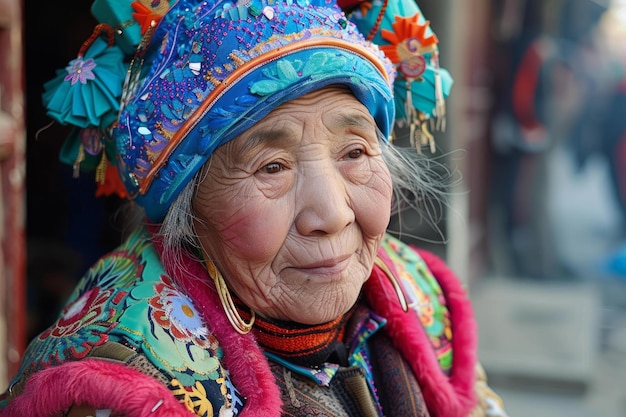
[157,236,477,417]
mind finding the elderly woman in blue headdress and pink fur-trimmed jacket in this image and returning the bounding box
[0,0,504,417]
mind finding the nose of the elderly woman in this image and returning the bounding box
[295,170,355,236]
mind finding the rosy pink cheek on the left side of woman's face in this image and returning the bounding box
[213,203,287,262]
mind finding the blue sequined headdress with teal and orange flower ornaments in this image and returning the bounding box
[44,0,450,222]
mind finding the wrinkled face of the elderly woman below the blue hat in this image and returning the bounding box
[193,88,392,324]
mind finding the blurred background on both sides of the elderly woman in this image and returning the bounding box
[0,0,626,417]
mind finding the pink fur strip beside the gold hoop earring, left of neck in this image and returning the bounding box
[155,232,282,417]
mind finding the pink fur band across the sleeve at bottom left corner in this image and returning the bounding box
[0,359,193,417]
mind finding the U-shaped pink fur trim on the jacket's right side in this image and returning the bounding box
[365,250,477,417]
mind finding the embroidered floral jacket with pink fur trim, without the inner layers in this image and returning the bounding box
[0,231,505,417]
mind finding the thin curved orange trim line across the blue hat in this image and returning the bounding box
[139,38,390,194]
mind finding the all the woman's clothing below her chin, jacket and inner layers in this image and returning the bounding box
[0,230,504,417]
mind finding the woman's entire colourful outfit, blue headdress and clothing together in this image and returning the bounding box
[0,0,503,417]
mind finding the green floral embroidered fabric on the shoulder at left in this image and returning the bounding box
[8,229,245,416]
